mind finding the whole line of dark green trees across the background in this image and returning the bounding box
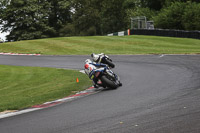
[0,0,200,41]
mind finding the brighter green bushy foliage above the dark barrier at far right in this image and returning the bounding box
[154,2,200,30]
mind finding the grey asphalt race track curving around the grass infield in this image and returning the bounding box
[0,55,200,133]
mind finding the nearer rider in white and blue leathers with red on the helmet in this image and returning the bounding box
[84,59,106,88]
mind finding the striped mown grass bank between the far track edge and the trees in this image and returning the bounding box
[0,35,200,55]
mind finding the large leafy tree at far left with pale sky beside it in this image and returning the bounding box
[2,0,55,41]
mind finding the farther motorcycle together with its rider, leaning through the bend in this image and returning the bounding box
[91,53,115,68]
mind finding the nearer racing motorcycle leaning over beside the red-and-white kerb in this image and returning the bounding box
[94,67,122,89]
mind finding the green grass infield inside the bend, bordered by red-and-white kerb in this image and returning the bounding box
[0,65,91,112]
